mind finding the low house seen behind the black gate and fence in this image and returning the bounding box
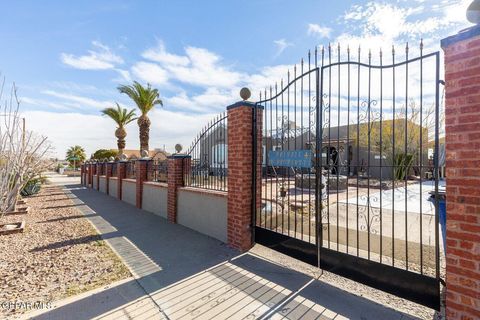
[197,119,429,179]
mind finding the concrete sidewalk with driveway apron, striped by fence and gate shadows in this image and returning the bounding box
[30,176,416,319]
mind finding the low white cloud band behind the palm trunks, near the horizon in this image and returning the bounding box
[22,108,216,158]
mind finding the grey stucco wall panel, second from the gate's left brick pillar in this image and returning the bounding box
[142,182,168,219]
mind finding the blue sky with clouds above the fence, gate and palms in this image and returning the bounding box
[0,0,470,157]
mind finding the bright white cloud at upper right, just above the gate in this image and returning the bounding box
[335,0,469,51]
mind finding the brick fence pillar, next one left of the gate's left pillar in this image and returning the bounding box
[167,154,191,223]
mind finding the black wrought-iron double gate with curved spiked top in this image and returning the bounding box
[252,44,441,309]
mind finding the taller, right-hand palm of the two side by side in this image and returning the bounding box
[118,81,163,151]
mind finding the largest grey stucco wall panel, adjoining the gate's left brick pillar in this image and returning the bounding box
[177,188,227,242]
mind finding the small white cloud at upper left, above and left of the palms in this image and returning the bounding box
[60,41,123,70]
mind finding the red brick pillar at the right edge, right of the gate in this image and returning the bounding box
[442,26,480,319]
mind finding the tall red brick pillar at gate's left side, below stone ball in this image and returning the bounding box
[227,101,263,251]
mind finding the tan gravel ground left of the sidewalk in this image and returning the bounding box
[0,186,130,318]
